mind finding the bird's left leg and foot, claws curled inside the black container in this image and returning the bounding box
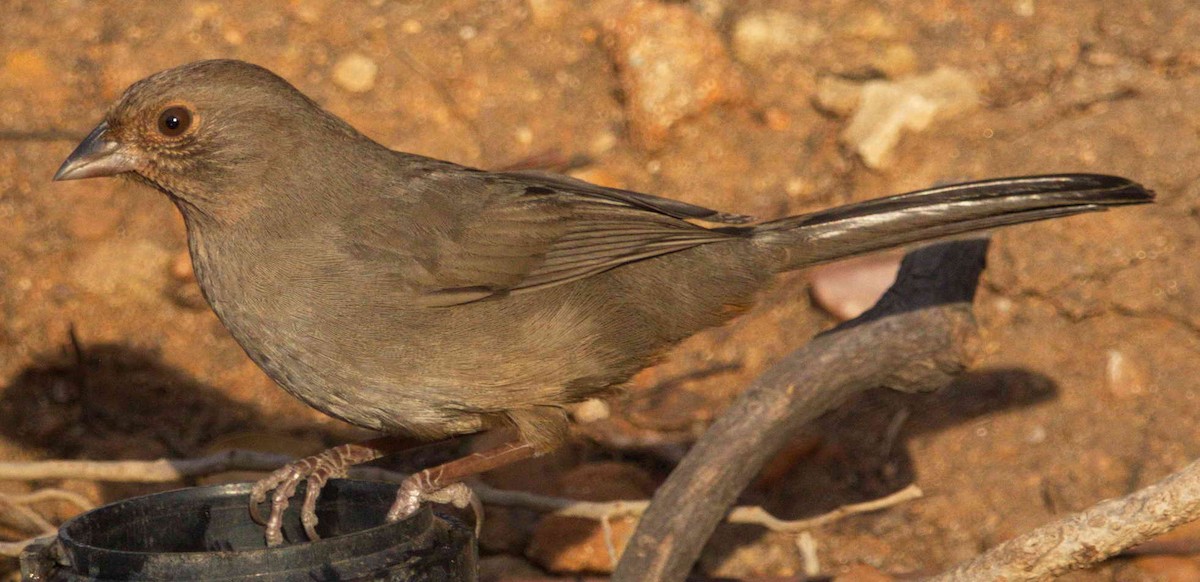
[250,437,402,547]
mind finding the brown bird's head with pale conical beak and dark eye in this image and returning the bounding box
[54,60,361,214]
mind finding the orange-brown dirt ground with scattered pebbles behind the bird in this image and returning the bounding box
[0,0,1200,581]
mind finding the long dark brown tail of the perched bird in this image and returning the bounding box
[754,174,1154,271]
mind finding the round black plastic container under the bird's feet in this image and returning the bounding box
[22,480,478,582]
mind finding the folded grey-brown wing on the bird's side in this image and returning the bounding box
[347,172,746,306]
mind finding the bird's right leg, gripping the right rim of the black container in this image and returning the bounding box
[388,440,538,523]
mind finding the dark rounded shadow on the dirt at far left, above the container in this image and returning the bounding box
[0,343,270,458]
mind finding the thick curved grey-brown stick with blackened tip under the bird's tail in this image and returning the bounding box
[612,240,988,582]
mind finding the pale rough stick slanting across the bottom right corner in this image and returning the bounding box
[931,461,1200,582]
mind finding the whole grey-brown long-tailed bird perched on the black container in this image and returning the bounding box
[54,60,1153,545]
